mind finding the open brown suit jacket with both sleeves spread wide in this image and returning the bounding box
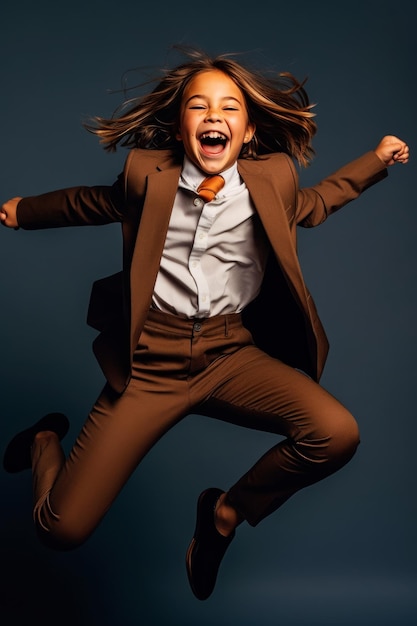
[18,149,387,393]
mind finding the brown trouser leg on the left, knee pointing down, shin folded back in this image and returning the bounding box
[34,382,188,549]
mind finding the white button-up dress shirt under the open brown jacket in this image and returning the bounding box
[152,157,269,318]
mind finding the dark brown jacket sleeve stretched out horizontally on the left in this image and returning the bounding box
[17,174,126,230]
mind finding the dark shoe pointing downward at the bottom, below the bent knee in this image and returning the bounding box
[186,487,235,600]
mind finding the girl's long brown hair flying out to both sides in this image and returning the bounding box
[84,48,316,166]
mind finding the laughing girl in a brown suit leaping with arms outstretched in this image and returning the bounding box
[0,46,409,600]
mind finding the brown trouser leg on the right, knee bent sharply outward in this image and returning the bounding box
[193,347,359,525]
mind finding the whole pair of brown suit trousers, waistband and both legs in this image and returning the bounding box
[32,310,359,549]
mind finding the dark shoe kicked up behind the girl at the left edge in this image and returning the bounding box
[3,413,69,474]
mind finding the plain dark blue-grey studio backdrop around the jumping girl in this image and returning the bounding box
[0,0,417,626]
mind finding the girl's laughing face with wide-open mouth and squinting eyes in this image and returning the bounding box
[176,70,255,174]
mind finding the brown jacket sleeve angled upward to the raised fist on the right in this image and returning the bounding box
[296,152,388,228]
